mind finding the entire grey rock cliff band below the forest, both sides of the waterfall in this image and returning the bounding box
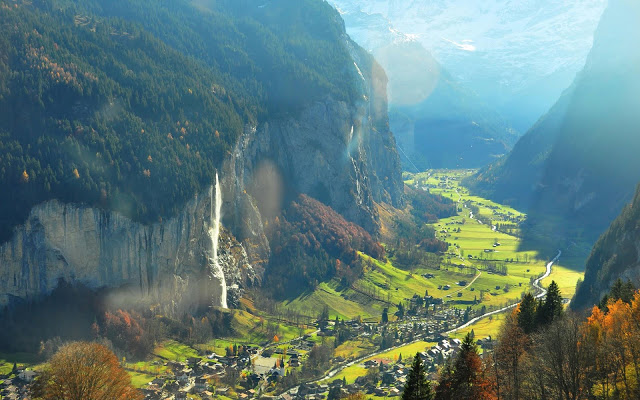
[0,37,403,313]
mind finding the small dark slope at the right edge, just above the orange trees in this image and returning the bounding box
[571,186,640,309]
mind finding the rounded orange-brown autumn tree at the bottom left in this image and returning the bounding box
[32,342,143,400]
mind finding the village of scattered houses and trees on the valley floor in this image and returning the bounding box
[0,295,496,400]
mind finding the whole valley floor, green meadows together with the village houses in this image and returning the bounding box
[0,171,582,399]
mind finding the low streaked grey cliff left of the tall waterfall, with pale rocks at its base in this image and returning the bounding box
[0,196,255,314]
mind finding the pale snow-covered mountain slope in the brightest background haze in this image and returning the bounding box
[332,0,607,132]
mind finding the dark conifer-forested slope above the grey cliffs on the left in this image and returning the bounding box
[0,0,368,241]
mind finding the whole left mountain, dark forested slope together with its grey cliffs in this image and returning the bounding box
[0,0,404,313]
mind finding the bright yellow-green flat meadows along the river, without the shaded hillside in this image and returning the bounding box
[409,171,582,336]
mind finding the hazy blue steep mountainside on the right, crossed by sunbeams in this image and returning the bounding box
[470,0,640,255]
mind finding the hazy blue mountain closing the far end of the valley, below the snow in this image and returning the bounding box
[332,5,518,171]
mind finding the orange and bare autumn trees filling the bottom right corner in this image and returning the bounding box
[490,283,640,400]
